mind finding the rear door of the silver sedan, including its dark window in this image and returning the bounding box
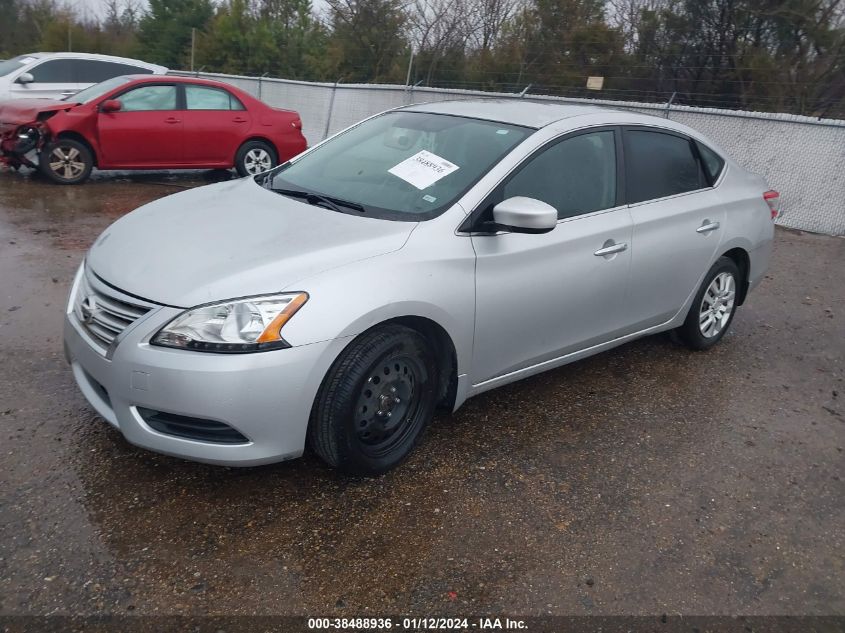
[624,127,725,330]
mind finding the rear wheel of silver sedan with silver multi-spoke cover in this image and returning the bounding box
[677,257,740,350]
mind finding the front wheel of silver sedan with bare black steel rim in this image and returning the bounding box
[308,325,438,475]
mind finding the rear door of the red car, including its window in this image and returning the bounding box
[183,84,252,167]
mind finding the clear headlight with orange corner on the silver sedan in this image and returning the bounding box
[150,292,308,353]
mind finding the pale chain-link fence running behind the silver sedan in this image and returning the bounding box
[179,73,845,235]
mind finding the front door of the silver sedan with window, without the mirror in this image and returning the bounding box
[472,128,632,386]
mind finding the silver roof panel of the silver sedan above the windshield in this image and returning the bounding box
[403,99,608,128]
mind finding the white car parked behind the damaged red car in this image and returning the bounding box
[0,53,167,100]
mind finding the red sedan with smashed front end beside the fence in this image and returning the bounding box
[0,75,307,184]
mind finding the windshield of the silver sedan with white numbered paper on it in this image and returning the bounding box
[264,111,533,221]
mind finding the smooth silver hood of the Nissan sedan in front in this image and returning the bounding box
[86,178,416,308]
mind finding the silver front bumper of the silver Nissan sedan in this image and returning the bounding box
[64,284,346,466]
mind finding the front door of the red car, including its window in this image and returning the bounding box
[97,83,185,169]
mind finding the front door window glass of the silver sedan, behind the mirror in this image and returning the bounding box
[502,130,616,219]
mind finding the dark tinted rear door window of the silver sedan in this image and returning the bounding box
[625,130,707,203]
